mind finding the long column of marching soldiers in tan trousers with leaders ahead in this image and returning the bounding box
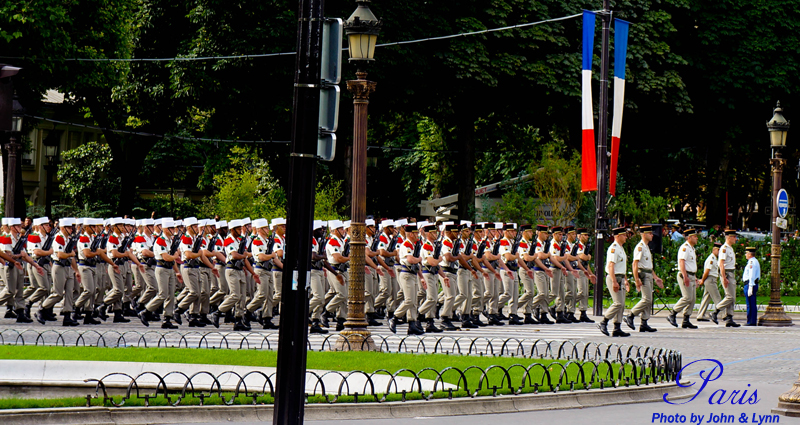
[0,217,752,337]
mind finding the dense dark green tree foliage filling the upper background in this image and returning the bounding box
[0,0,800,228]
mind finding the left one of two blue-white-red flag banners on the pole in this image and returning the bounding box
[581,10,597,192]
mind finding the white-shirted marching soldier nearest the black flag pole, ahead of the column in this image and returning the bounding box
[597,227,631,337]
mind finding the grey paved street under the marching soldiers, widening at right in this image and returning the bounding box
[0,313,800,425]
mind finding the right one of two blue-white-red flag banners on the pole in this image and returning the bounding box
[608,19,630,196]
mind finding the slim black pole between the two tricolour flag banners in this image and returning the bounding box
[594,0,611,316]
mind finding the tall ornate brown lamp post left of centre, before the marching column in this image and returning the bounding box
[337,0,382,351]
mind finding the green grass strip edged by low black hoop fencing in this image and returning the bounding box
[0,346,652,409]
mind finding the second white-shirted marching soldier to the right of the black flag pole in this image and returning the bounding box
[625,226,664,332]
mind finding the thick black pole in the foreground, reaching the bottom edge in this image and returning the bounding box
[272,0,324,425]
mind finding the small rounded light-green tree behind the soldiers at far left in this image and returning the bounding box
[58,142,121,210]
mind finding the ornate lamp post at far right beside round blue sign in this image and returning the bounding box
[758,102,792,326]
